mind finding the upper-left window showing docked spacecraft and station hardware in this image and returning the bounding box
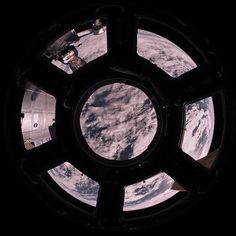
[44,19,107,74]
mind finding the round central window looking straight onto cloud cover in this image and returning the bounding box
[80,83,158,161]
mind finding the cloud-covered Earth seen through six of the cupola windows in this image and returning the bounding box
[45,30,214,211]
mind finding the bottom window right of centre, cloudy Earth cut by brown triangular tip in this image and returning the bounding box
[123,173,178,211]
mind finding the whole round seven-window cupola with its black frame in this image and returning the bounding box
[6,0,230,230]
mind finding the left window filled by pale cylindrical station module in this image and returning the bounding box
[21,84,56,149]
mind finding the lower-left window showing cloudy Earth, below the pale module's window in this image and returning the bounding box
[48,162,99,206]
